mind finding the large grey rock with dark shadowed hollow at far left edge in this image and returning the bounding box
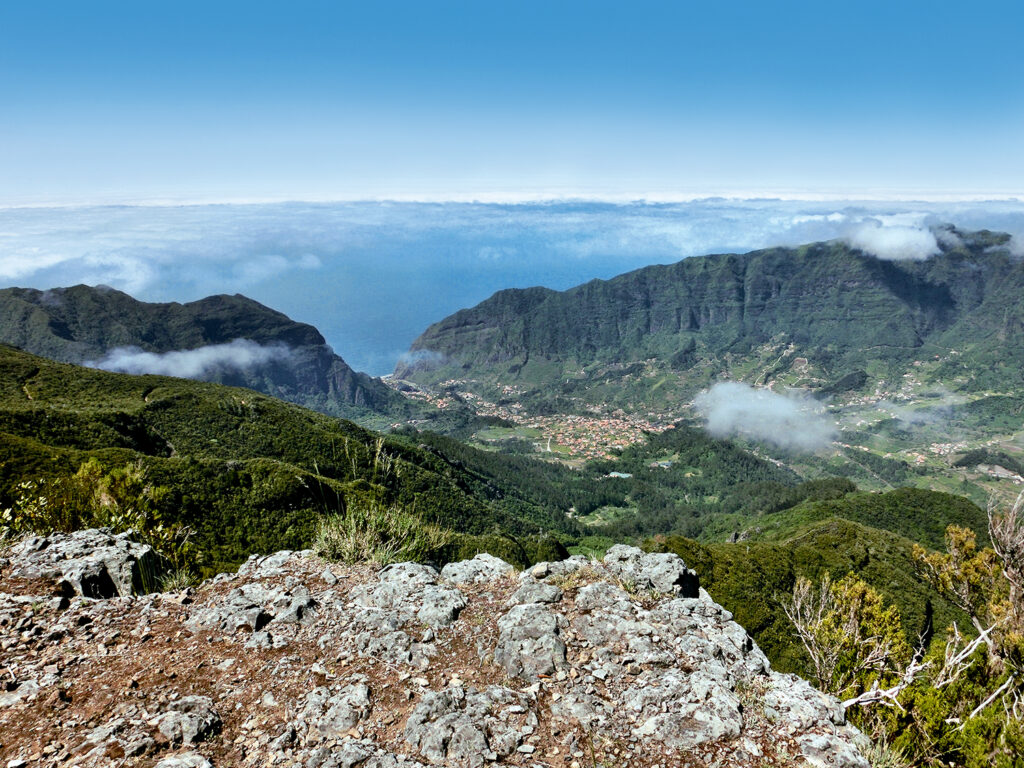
[10,528,160,598]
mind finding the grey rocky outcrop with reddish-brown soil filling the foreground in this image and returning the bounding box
[0,530,867,768]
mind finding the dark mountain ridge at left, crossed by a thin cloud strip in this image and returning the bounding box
[0,286,409,416]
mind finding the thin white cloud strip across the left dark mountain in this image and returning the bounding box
[85,339,290,380]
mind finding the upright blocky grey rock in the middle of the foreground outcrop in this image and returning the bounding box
[495,603,566,678]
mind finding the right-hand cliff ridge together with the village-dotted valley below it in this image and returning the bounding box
[389,227,1024,514]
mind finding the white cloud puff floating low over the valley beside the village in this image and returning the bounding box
[693,381,836,452]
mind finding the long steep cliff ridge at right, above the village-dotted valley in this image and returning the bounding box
[395,227,1024,397]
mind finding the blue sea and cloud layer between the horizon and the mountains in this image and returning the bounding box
[0,199,1024,375]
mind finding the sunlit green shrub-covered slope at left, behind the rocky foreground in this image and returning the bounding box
[0,345,578,564]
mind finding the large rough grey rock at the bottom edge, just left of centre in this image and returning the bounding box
[406,685,537,768]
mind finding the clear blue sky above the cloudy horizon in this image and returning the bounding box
[0,0,1024,204]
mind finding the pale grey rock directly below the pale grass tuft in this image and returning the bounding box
[352,562,466,627]
